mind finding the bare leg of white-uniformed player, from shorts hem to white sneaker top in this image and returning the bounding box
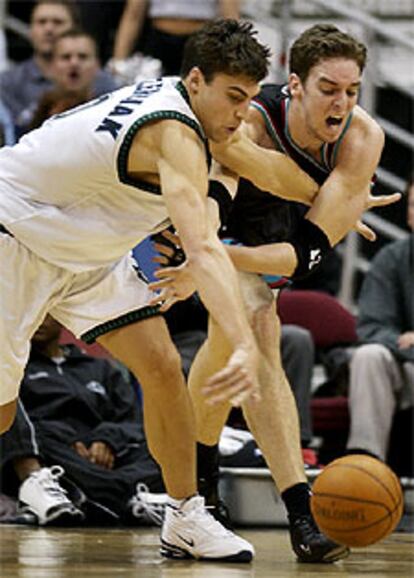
[99,317,197,499]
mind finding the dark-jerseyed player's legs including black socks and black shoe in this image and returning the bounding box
[190,273,348,562]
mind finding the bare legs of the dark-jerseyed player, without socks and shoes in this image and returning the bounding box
[189,274,306,491]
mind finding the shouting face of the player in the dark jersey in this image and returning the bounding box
[295,58,361,143]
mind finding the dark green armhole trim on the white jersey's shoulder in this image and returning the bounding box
[117,110,208,195]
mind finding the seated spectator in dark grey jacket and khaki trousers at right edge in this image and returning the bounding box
[347,181,414,460]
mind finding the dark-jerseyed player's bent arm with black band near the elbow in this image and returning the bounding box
[222,107,401,277]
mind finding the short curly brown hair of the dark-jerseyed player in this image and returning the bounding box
[289,24,367,82]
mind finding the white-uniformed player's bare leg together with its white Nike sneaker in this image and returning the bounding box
[99,317,254,562]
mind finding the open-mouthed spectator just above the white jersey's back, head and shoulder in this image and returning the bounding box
[30,29,99,128]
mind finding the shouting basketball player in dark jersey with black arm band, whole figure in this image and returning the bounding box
[146,25,400,562]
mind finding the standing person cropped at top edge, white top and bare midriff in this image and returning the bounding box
[110,0,240,75]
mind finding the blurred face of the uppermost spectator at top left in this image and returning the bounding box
[30,4,73,56]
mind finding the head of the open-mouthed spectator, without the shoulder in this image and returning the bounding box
[53,36,98,92]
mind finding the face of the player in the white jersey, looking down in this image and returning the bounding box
[187,69,259,142]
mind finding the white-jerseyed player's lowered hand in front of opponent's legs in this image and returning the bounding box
[203,346,260,407]
